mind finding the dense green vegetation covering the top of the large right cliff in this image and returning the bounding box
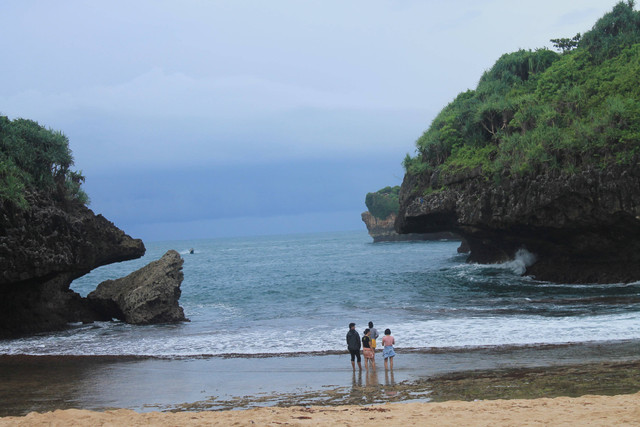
[403,1,640,186]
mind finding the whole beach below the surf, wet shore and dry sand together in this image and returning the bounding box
[0,345,640,426]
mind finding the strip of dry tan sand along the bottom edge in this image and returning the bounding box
[0,392,640,427]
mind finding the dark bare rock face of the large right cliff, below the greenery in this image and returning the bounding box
[396,163,640,283]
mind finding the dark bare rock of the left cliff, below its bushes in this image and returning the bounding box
[0,193,145,337]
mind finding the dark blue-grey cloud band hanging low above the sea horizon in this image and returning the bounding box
[86,157,403,225]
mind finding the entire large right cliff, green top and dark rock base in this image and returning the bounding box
[396,2,640,283]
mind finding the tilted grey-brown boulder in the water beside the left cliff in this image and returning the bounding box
[87,250,187,324]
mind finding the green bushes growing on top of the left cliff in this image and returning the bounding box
[0,116,89,209]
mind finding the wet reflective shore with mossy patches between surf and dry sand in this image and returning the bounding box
[0,341,640,416]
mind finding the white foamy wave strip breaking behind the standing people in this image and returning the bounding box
[5,313,640,356]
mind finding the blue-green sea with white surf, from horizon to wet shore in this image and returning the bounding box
[0,231,640,358]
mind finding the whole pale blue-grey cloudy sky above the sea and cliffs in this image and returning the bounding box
[0,0,616,241]
